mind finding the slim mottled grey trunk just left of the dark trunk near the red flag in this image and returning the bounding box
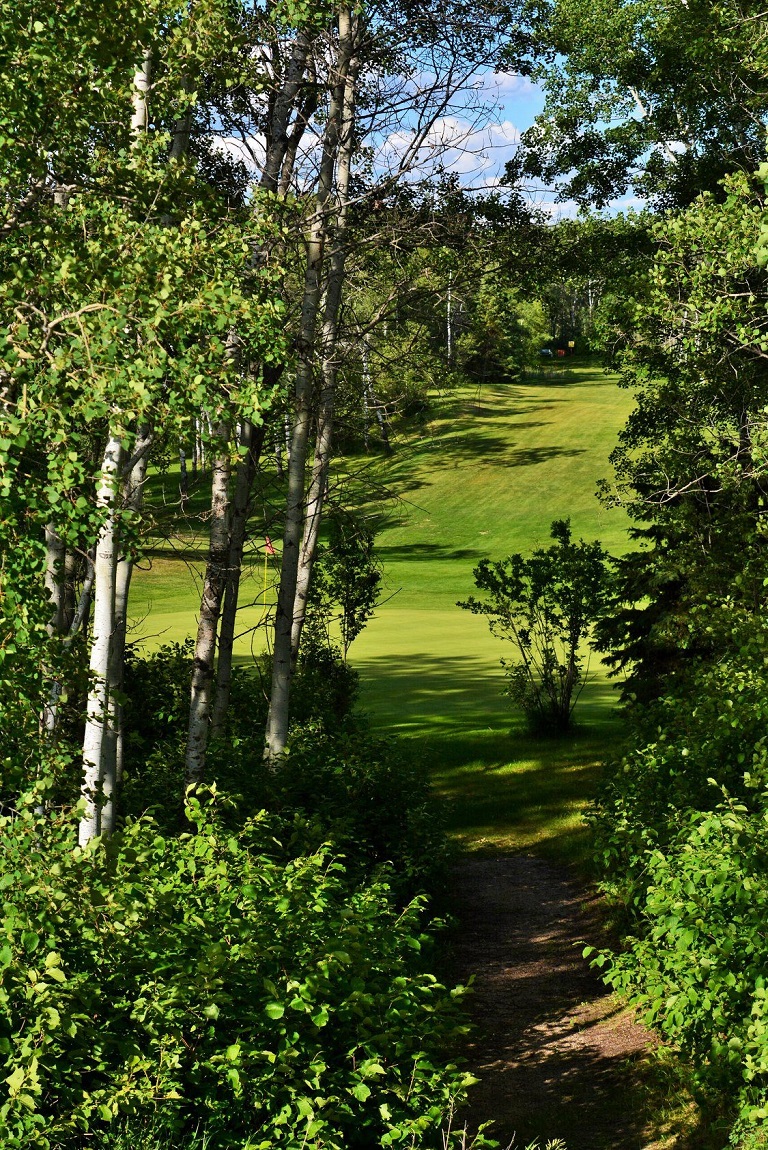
[186,420,231,783]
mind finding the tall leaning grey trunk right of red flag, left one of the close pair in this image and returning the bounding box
[264,7,356,764]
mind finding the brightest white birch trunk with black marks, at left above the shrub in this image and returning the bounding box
[78,432,122,846]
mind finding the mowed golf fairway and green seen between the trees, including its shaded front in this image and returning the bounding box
[132,365,631,856]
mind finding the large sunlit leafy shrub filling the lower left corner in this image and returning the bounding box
[0,796,473,1150]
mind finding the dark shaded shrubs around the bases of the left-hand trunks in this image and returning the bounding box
[122,644,447,900]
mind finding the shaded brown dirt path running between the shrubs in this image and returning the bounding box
[454,856,652,1150]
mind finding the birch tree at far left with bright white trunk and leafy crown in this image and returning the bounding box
[0,0,287,843]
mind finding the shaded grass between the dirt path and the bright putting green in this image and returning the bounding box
[355,656,621,863]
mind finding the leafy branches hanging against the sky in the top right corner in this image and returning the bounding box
[515,0,767,208]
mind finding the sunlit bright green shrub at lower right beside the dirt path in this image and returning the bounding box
[598,775,768,1144]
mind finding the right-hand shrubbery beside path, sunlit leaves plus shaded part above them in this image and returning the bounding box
[594,603,768,1131]
